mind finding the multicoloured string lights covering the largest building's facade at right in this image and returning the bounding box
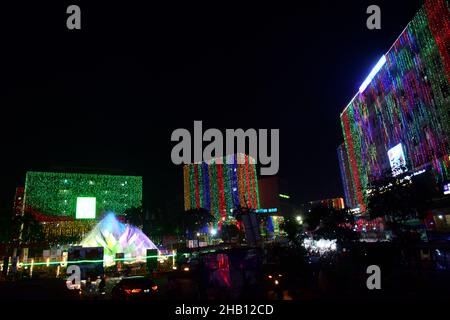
[338,0,450,211]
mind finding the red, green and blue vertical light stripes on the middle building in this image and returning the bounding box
[183,154,259,220]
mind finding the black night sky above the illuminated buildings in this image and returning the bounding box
[0,0,422,214]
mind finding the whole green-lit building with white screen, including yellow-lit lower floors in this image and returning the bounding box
[22,172,142,242]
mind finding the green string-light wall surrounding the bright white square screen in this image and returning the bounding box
[24,172,142,218]
